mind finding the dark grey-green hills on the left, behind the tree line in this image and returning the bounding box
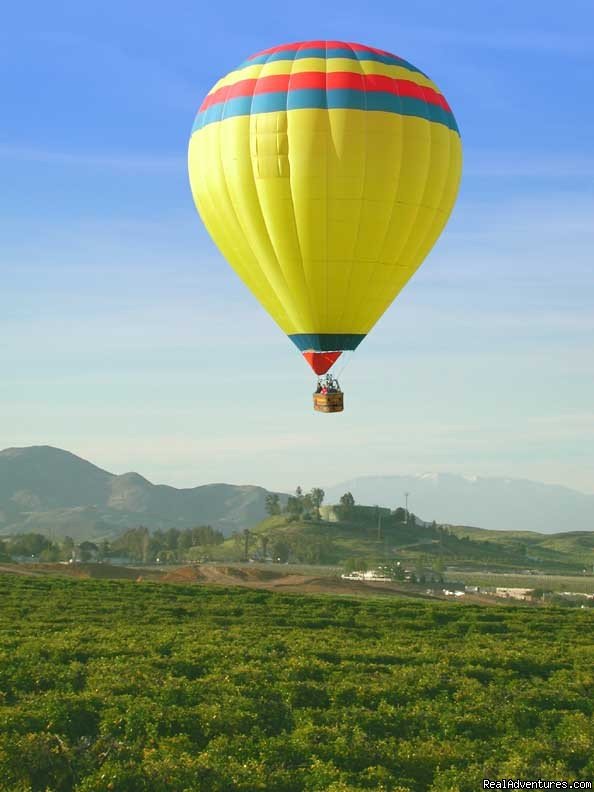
[0,446,284,541]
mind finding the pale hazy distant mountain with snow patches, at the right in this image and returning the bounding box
[326,473,594,533]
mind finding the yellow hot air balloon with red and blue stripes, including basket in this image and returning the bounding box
[188,41,462,412]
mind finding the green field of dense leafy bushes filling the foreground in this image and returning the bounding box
[0,576,594,792]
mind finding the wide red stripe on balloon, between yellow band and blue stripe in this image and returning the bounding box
[200,72,451,112]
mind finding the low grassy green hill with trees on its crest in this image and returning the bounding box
[214,506,594,573]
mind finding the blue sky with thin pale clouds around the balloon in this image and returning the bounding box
[0,0,594,492]
